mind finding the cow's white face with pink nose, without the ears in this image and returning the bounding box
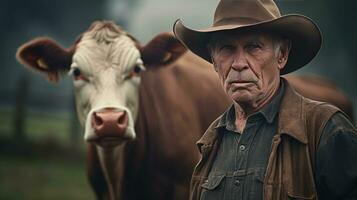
[69,25,144,146]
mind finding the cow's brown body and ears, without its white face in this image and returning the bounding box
[18,22,352,200]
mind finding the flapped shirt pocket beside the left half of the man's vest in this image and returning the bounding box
[200,175,225,200]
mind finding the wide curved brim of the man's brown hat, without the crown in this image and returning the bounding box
[173,14,322,74]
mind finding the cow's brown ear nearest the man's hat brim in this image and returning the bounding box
[141,32,186,67]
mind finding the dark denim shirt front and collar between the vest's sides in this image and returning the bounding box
[201,81,284,200]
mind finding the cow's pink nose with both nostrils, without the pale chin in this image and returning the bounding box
[92,110,128,139]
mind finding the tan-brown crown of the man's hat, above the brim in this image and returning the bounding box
[213,0,281,27]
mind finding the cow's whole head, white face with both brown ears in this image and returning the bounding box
[17,22,185,146]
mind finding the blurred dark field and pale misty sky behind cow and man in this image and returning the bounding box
[0,0,357,200]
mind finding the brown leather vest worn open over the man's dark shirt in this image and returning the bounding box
[190,82,338,200]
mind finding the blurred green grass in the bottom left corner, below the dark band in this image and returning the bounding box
[0,157,95,200]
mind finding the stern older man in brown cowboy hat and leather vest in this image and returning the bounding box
[174,0,357,200]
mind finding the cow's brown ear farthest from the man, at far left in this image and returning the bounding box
[16,38,74,82]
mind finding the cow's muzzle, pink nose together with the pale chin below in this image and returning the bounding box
[90,108,129,147]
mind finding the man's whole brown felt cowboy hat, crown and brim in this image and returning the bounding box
[173,0,322,74]
